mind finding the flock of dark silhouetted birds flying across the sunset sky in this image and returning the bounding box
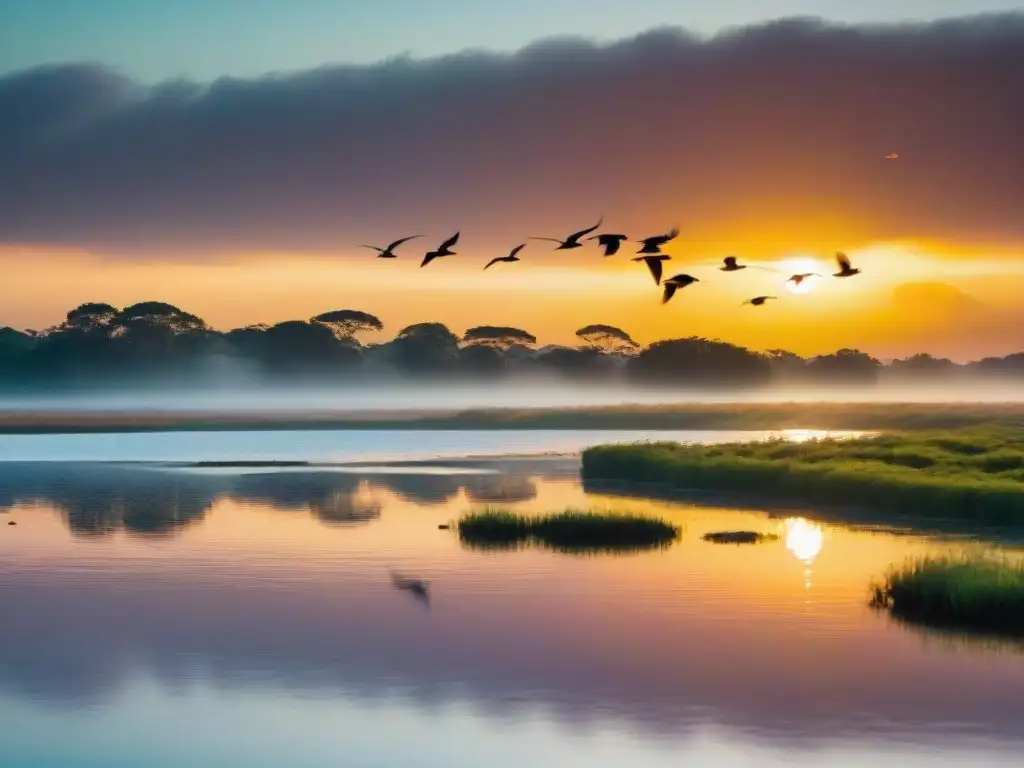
[361,216,860,306]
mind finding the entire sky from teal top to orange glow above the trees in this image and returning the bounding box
[0,0,1024,359]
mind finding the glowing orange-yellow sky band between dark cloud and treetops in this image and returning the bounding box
[8,241,1024,359]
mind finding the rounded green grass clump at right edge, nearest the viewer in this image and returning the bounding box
[871,555,1024,637]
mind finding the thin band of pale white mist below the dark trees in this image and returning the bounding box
[0,376,1024,414]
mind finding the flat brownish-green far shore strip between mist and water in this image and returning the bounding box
[0,402,1024,434]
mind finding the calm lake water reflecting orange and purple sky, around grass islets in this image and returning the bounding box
[0,432,1024,768]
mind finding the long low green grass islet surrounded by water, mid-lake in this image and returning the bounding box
[457,509,680,553]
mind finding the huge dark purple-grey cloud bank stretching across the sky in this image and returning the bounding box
[0,15,1024,255]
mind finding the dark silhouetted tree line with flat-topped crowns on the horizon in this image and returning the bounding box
[0,301,1024,389]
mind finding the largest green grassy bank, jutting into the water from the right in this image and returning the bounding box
[583,427,1024,524]
